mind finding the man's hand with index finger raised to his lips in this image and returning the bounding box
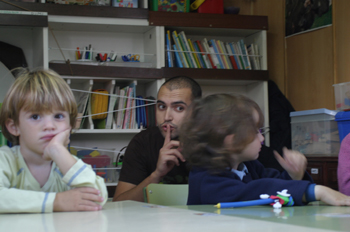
[152,125,185,182]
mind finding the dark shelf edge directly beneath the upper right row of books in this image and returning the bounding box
[163,68,269,81]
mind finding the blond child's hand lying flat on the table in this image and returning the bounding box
[53,187,104,212]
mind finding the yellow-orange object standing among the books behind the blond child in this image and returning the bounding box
[91,89,108,119]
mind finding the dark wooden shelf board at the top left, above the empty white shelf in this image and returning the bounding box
[0,1,148,18]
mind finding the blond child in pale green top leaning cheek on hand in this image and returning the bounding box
[0,70,107,213]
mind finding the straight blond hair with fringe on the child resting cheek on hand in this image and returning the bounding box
[0,69,77,144]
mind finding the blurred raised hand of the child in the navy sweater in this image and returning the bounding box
[274,147,307,180]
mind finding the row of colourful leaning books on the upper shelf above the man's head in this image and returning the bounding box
[165,30,261,70]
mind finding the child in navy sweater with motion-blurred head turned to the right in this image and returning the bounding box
[180,94,350,206]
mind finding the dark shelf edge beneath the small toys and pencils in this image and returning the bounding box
[49,63,163,79]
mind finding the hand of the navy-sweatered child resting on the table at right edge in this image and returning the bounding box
[315,185,350,206]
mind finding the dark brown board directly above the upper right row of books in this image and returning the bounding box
[148,11,268,30]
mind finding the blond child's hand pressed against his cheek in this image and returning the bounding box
[43,128,71,160]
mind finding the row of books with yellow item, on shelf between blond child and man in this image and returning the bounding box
[73,83,156,129]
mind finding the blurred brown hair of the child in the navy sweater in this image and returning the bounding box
[180,94,264,169]
